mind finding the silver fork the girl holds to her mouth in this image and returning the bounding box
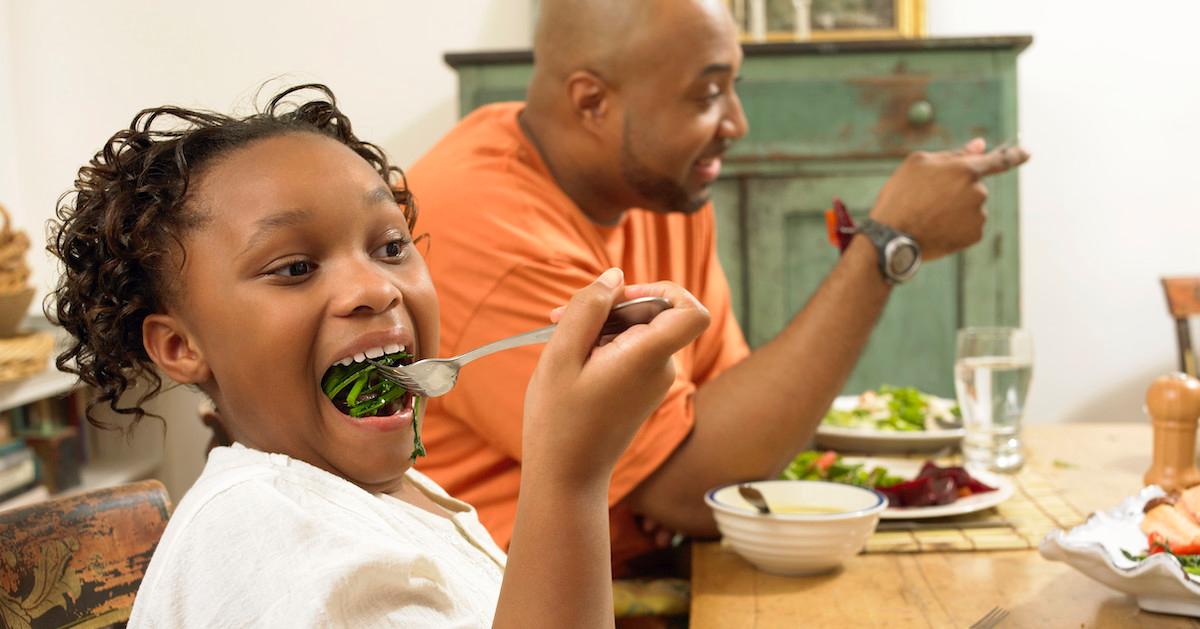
[367,296,671,397]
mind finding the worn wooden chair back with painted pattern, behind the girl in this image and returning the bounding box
[0,480,170,629]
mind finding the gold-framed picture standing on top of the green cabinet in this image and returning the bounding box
[727,0,925,42]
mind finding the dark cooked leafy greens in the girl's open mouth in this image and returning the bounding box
[320,352,425,459]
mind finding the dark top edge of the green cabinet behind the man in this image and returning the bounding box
[443,35,1033,70]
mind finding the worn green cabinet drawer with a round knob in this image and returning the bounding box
[730,54,1015,163]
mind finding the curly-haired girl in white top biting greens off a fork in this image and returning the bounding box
[49,85,708,627]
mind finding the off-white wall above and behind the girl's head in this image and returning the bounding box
[0,0,532,499]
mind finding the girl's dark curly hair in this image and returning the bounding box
[44,84,416,429]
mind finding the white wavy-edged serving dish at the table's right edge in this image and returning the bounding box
[1038,485,1200,616]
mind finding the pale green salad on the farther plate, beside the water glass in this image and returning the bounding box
[822,385,962,432]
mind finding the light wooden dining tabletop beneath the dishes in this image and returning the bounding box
[691,421,1200,629]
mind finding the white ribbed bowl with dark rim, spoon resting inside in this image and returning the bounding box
[704,480,888,575]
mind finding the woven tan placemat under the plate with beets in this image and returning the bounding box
[864,468,1087,552]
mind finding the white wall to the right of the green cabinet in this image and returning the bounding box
[926,0,1200,421]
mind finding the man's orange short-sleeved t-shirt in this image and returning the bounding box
[408,103,749,563]
